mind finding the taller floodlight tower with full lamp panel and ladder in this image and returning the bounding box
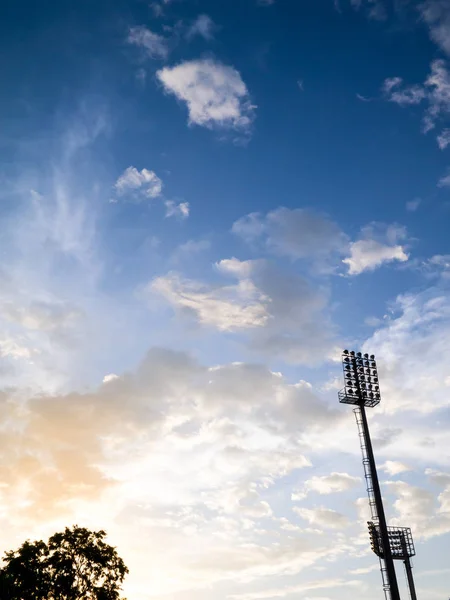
[338,350,400,600]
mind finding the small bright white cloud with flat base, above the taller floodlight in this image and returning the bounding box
[342,226,409,275]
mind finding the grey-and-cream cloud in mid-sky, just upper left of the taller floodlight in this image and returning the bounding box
[150,258,335,363]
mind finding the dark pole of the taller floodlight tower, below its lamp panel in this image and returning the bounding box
[359,400,400,600]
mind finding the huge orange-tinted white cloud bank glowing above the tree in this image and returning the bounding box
[0,349,352,597]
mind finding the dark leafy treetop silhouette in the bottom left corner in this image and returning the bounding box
[0,525,128,600]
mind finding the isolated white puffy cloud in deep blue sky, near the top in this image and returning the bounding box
[156,60,254,132]
